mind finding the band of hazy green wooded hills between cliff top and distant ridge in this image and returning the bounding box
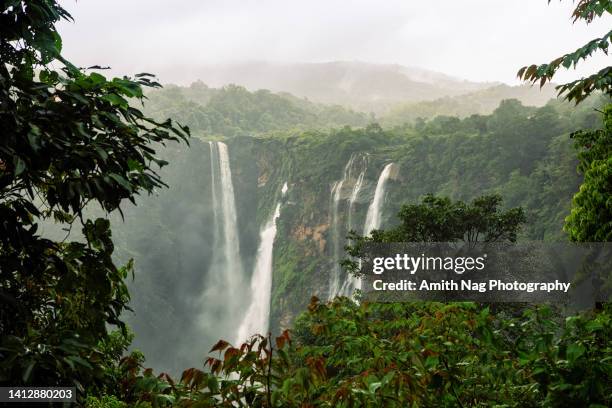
[146,81,555,137]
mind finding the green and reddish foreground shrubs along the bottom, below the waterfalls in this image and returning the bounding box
[89,298,612,408]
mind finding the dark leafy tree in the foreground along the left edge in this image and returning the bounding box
[0,0,189,391]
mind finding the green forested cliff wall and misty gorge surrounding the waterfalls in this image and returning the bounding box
[109,89,604,370]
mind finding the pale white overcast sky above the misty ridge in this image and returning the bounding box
[60,0,612,83]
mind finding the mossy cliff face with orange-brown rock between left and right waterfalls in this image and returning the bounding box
[220,138,400,331]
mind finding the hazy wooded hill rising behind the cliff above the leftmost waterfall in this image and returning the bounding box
[147,82,371,137]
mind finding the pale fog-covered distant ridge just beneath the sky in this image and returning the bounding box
[164,61,499,113]
